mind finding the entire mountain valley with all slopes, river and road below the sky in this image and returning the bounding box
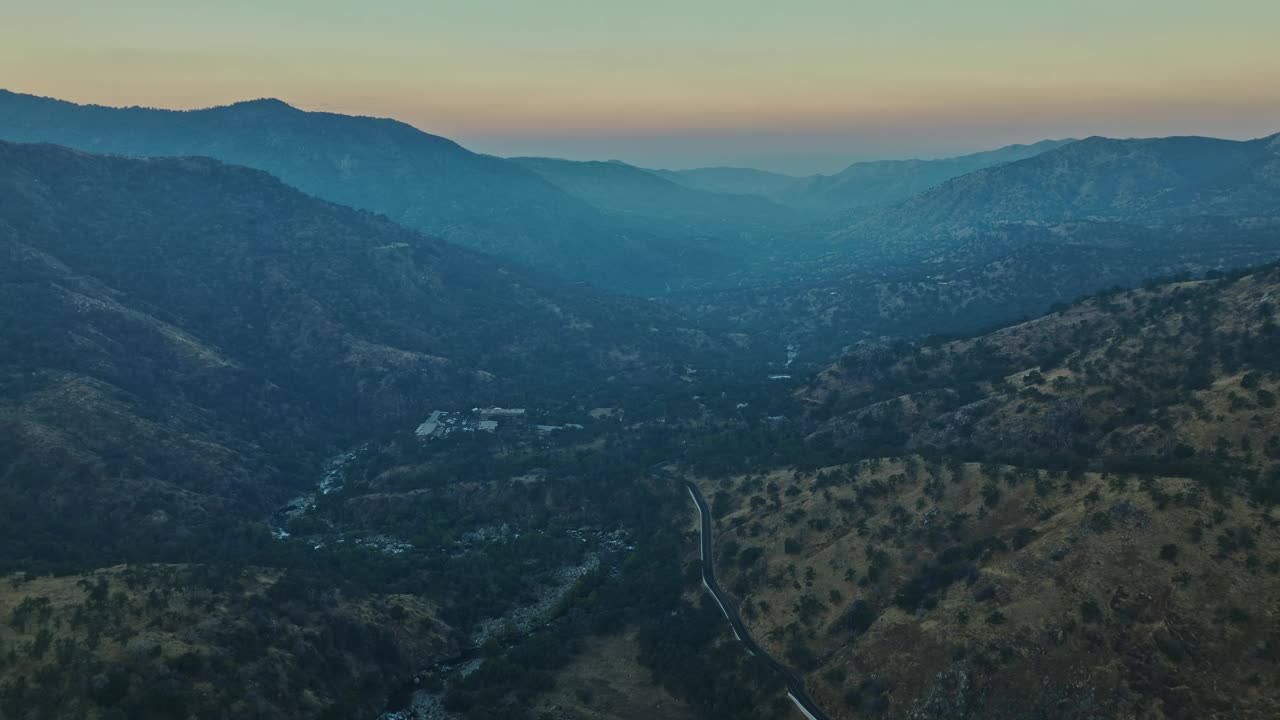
[0,91,1280,720]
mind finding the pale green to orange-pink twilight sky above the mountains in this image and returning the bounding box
[0,0,1280,174]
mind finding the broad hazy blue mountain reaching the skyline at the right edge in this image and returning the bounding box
[829,136,1280,258]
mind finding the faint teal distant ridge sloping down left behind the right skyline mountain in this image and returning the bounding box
[776,140,1075,213]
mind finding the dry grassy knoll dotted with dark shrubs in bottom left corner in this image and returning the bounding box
[0,565,456,720]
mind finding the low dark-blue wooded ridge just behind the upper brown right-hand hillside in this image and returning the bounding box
[686,218,1280,360]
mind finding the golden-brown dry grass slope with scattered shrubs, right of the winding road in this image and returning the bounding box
[703,456,1280,719]
